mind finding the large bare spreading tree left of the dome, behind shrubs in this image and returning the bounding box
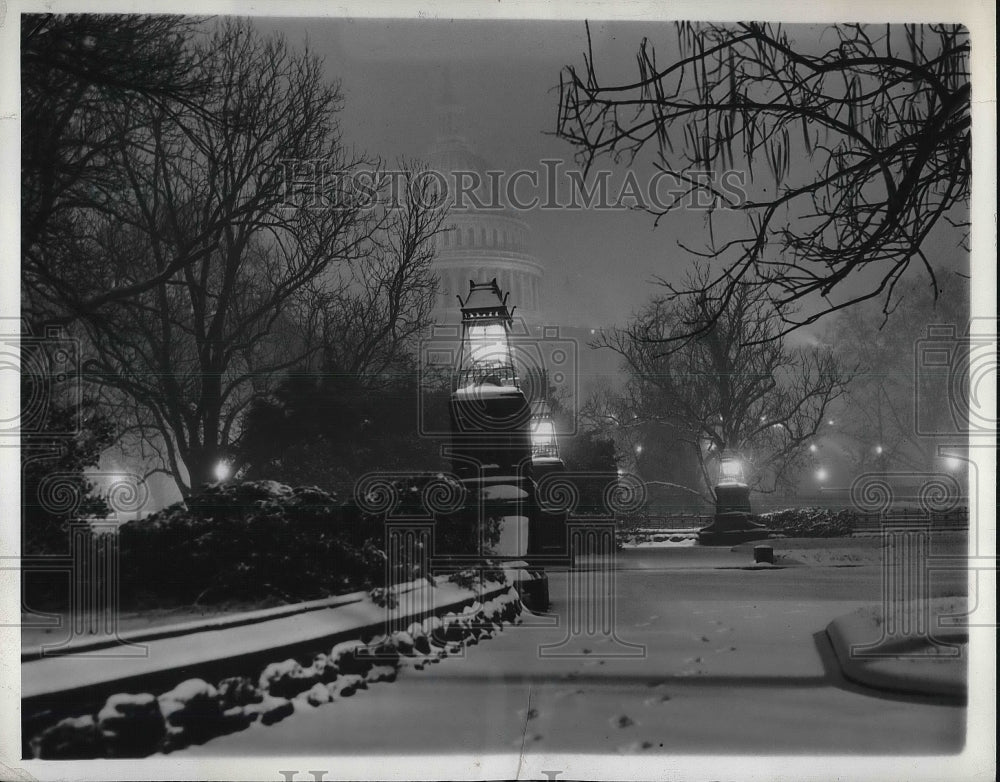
[71,22,430,494]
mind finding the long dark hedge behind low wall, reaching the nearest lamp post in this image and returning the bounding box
[119,474,496,606]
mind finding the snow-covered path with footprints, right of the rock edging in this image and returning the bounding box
[177,549,965,757]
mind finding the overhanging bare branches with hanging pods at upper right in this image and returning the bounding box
[556,23,971,335]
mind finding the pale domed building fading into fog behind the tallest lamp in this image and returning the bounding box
[423,74,544,325]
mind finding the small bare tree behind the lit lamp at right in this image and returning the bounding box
[596,269,847,492]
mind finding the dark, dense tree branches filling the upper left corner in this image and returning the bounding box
[21,14,208,326]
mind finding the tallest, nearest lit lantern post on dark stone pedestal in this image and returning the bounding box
[449,279,548,608]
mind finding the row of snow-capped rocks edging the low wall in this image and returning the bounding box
[24,582,523,759]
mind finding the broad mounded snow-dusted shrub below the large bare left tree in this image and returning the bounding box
[120,481,385,603]
